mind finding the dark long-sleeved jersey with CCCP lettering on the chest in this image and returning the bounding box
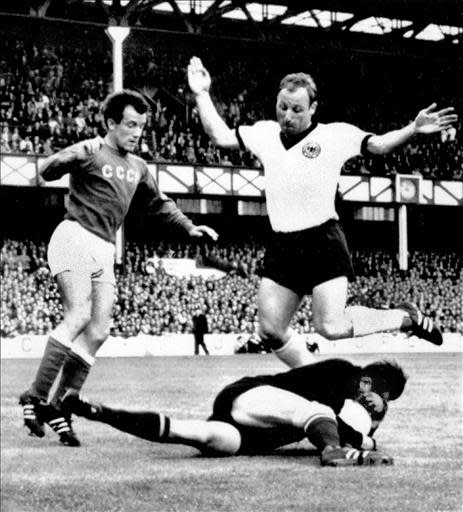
[41,144,193,243]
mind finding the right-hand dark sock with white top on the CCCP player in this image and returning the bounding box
[51,346,95,406]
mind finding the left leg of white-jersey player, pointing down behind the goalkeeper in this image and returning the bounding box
[257,277,315,368]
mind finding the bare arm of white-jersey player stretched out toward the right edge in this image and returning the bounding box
[367,103,458,155]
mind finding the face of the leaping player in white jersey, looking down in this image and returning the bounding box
[276,87,317,135]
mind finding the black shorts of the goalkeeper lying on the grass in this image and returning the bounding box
[208,376,303,455]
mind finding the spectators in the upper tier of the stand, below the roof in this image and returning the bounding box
[0,28,463,179]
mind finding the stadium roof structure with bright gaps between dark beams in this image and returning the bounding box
[0,0,463,48]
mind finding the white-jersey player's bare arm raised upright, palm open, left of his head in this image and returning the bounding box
[188,57,239,149]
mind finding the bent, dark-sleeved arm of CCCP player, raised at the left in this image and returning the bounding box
[40,137,103,181]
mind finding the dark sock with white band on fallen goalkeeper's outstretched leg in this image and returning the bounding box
[97,405,170,442]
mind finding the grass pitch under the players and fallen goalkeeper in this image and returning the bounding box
[1,353,463,512]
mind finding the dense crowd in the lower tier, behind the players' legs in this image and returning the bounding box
[0,239,463,337]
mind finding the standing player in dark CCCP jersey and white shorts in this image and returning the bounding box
[19,90,218,446]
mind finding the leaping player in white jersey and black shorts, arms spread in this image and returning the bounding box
[188,57,457,367]
